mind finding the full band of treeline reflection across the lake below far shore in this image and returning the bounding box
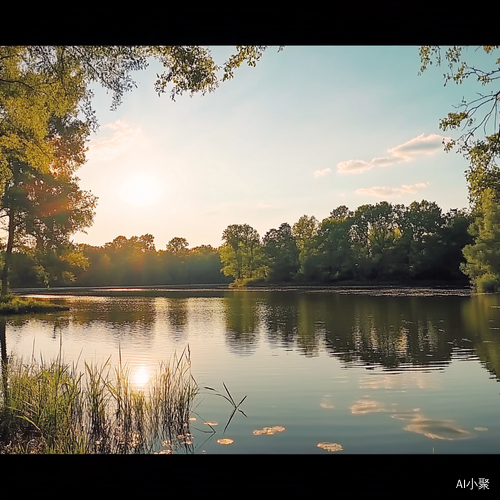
[3,290,500,377]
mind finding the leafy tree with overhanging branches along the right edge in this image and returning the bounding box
[420,45,500,288]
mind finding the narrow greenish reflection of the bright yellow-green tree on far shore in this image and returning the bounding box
[224,292,262,354]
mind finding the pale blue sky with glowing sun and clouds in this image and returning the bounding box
[73,46,492,250]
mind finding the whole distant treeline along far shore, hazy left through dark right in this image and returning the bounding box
[3,200,473,287]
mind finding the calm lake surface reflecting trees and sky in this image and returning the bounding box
[5,288,500,454]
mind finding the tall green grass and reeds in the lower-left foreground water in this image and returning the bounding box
[0,348,198,454]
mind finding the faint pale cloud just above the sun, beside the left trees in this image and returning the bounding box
[87,120,142,161]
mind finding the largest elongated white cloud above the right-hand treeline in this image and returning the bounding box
[337,134,450,174]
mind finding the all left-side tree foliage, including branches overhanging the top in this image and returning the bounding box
[0,45,281,295]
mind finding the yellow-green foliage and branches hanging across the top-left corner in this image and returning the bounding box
[0,45,281,191]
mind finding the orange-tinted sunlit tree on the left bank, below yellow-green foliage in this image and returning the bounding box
[0,113,97,295]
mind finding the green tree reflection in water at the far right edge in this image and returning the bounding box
[461,294,500,379]
